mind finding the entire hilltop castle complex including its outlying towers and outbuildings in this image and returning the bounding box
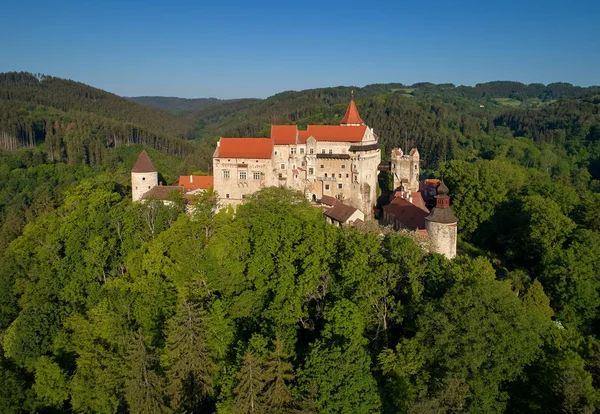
[131,100,458,258]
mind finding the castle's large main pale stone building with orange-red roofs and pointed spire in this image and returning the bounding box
[213,101,381,216]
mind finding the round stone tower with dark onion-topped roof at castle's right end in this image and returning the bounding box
[425,181,458,259]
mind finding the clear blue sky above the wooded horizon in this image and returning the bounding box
[0,0,600,98]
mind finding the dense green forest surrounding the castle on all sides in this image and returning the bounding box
[0,74,600,413]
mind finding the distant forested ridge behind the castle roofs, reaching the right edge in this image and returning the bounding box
[188,81,600,144]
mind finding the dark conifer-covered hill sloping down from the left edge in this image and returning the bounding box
[0,72,198,164]
